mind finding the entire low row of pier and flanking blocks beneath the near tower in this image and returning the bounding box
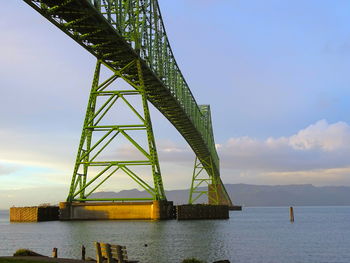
[10,201,229,222]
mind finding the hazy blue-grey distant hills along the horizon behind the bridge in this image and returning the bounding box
[91,184,350,206]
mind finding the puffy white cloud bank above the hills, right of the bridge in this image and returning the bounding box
[219,120,350,171]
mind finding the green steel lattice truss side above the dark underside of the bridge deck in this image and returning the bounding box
[91,0,219,171]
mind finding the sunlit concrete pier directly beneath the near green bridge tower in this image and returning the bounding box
[59,201,174,220]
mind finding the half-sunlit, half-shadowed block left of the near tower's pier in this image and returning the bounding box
[10,206,58,222]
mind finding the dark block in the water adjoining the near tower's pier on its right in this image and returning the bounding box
[176,204,229,220]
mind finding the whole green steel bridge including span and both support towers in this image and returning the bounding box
[24,0,232,205]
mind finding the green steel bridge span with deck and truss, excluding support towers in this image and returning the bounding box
[24,0,232,206]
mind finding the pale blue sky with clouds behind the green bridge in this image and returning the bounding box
[0,0,350,209]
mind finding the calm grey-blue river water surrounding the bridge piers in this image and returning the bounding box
[0,207,350,263]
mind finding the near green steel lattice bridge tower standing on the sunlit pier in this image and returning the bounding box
[67,59,166,202]
